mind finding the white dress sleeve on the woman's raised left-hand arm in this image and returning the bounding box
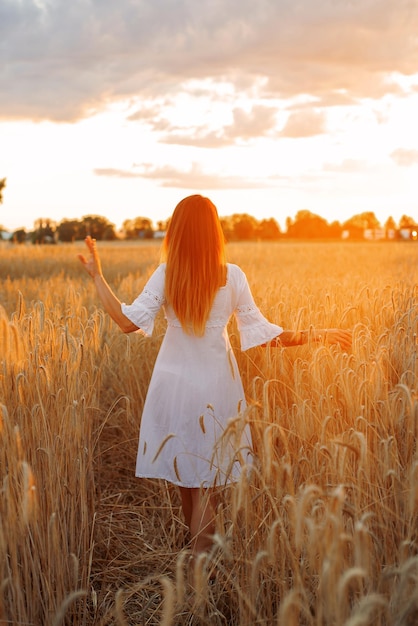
[122,264,165,335]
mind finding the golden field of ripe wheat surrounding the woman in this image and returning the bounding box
[0,236,418,626]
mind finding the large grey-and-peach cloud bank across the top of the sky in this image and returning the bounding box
[0,0,418,120]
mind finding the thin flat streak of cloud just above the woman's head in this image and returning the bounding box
[94,163,272,190]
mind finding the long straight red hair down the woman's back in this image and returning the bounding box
[162,195,226,336]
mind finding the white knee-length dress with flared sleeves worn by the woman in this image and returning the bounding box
[122,263,283,487]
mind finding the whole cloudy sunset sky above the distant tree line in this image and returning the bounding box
[0,0,418,230]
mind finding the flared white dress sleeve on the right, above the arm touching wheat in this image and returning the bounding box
[234,268,283,351]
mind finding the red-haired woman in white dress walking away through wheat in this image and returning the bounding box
[79,195,351,555]
